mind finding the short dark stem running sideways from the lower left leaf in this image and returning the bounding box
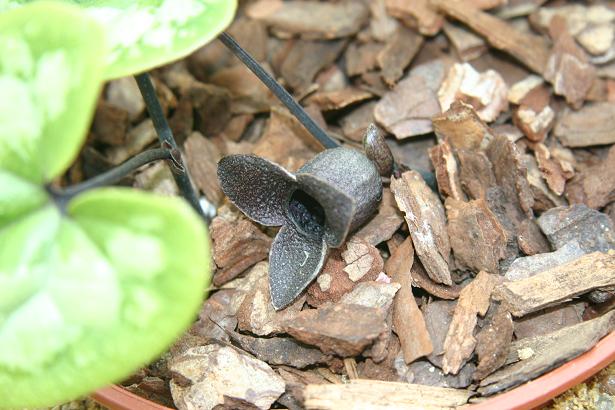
[55,148,173,202]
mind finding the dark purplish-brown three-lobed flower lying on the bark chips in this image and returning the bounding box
[218,148,382,309]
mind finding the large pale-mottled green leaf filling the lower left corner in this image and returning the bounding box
[0,188,210,408]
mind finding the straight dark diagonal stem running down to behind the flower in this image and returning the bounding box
[218,32,340,148]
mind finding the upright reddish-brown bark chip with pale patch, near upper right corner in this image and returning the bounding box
[543,16,596,109]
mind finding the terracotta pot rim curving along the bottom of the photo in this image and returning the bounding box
[91,331,615,410]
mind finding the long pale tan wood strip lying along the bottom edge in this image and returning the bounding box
[303,380,472,410]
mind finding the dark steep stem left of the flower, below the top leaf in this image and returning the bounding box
[135,73,205,218]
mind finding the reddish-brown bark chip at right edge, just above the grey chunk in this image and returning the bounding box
[566,147,615,209]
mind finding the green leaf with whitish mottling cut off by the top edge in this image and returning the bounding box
[0,0,237,79]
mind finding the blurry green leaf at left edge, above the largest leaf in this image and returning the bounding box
[0,2,104,183]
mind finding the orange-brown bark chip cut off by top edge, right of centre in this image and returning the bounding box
[385,0,444,36]
